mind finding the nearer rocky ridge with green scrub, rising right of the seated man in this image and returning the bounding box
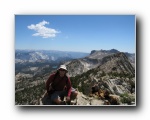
[67,52,135,105]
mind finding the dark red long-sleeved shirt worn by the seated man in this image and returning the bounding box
[46,73,71,96]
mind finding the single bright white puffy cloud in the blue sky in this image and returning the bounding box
[27,20,60,38]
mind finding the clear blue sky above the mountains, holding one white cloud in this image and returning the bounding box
[15,15,136,53]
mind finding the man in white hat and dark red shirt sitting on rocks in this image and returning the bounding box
[46,65,78,105]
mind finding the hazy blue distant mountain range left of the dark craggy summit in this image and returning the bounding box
[15,50,89,63]
